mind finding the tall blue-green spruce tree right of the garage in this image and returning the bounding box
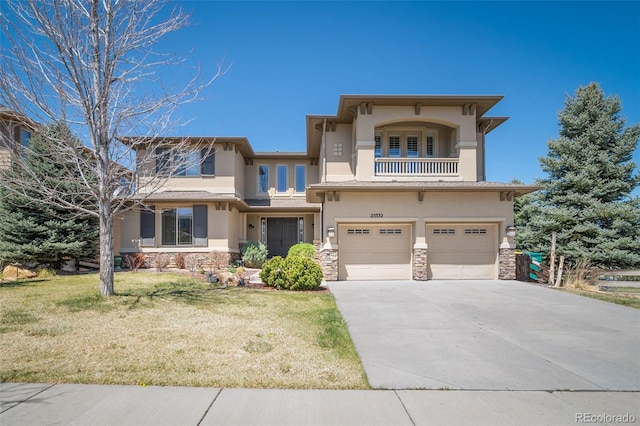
[515,83,640,268]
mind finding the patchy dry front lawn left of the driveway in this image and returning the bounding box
[0,273,368,389]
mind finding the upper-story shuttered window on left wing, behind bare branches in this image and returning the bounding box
[156,148,215,176]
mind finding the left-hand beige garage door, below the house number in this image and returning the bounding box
[338,224,411,280]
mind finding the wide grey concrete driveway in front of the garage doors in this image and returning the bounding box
[329,281,640,391]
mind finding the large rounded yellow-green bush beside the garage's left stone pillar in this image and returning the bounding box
[260,255,322,290]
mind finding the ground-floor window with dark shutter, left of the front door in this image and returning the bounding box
[162,205,207,246]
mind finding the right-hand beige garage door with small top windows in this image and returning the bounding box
[427,223,498,280]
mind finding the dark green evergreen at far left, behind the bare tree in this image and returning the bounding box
[0,124,99,268]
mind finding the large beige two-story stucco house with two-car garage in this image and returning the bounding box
[119,95,537,280]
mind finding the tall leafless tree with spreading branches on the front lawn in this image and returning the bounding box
[0,0,222,296]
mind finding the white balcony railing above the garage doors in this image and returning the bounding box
[375,158,458,176]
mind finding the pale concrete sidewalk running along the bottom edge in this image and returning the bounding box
[0,383,640,426]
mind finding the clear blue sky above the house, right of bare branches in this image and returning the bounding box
[162,1,640,189]
